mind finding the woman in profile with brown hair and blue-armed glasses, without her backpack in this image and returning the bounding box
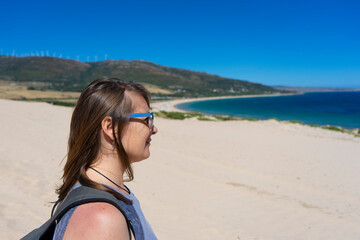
[53,78,158,240]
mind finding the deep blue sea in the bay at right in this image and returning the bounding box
[176,91,360,129]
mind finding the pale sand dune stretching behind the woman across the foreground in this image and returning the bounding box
[0,100,360,240]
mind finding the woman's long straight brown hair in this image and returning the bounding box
[56,77,150,202]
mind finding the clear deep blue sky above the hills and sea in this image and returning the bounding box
[0,0,360,88]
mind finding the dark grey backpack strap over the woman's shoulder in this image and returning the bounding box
[21,186,131,240]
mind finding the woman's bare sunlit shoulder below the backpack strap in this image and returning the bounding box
[63,202,129,240]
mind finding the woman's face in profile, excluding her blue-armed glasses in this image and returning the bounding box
[121,92,158,163]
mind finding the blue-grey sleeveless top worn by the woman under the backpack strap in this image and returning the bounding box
[53,184,157,240]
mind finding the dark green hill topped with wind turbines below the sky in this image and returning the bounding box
[0,56,288,97]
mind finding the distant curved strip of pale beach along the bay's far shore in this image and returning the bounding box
[151,92,304,113]
